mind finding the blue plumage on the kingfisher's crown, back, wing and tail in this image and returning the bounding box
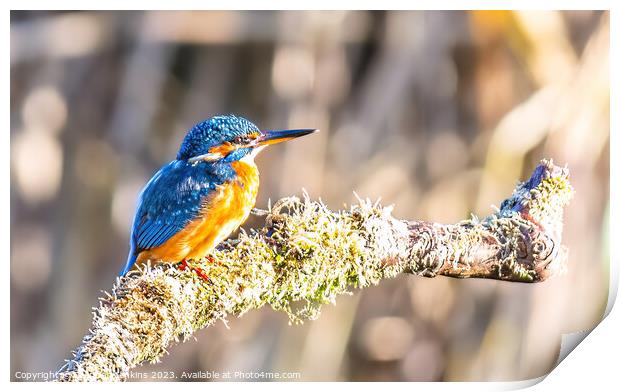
[121,115,260,275]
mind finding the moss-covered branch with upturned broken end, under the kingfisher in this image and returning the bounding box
[57,160,573,381]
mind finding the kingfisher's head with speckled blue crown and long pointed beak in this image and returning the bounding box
[177,115,318,162]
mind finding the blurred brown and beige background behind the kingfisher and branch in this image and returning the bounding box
[10,11,609,381]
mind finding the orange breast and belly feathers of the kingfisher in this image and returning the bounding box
[136,161,258,263]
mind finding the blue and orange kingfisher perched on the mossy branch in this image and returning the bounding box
[120,115,318,276]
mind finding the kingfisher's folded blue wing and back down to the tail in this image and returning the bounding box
[121,161,229,275]
